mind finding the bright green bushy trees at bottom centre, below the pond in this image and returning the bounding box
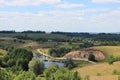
[44,64,81,80]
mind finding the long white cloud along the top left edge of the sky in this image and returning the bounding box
[0,0,61,7]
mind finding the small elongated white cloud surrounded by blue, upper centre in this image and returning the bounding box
[57,3,85,8]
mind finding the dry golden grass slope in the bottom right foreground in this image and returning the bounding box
[75,62,120,80]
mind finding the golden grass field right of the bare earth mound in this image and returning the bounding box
[93,46,120,57]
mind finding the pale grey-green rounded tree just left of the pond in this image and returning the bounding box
[29,58,44,75]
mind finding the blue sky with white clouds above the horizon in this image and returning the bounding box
[0,0,120,32]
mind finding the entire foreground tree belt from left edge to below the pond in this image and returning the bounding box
[0,48,81,80]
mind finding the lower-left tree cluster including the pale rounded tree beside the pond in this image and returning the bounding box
[0,48,44,80]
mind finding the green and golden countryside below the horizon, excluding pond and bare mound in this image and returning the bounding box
[0,31,120,80]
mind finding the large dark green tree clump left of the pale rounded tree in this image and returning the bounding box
[4,49,33,70]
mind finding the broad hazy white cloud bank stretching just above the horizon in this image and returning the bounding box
[0,8,120,31]
